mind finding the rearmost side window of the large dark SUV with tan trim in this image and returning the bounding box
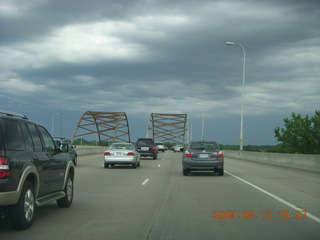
[0,119,26,150]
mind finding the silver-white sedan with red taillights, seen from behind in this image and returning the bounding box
[104,143,140,168]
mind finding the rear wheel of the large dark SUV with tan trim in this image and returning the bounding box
[9,181,35,230]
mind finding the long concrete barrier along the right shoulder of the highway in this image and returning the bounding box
[223,150,320,172]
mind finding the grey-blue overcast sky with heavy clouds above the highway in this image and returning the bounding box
[0,0,320,145]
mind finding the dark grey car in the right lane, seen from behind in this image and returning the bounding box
[182,141,224,176]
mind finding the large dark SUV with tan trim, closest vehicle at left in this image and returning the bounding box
[0,110,74,229]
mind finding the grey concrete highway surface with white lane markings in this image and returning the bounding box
[0,151,320,240]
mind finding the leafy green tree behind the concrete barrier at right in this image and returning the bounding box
[274,111,320,154]
